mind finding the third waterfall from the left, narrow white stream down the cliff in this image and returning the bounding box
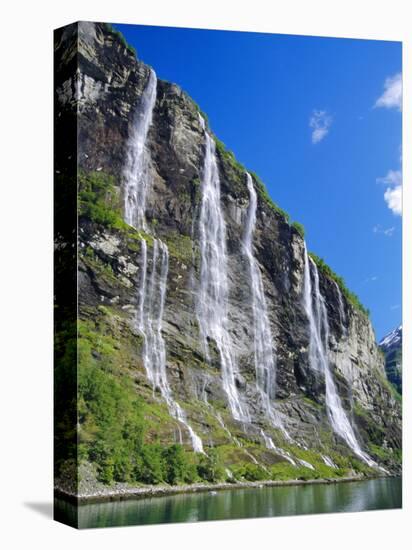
[243,172,280,430]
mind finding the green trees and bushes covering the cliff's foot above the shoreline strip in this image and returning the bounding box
[73,305,368,485]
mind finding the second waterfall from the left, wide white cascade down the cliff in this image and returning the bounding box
[196,117,249,422]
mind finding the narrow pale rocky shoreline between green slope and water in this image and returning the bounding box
[54,475,392,505]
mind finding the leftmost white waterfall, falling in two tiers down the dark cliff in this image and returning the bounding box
[124,70,203,452]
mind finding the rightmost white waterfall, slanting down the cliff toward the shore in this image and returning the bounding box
[304,245,376,466]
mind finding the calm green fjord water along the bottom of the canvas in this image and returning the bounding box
[55,478,402,529]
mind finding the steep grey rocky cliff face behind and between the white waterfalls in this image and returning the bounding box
[56,23,401,490]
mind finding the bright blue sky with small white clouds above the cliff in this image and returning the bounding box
[115,25,402,339]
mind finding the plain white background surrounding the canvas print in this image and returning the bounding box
[0,0,412,550]
